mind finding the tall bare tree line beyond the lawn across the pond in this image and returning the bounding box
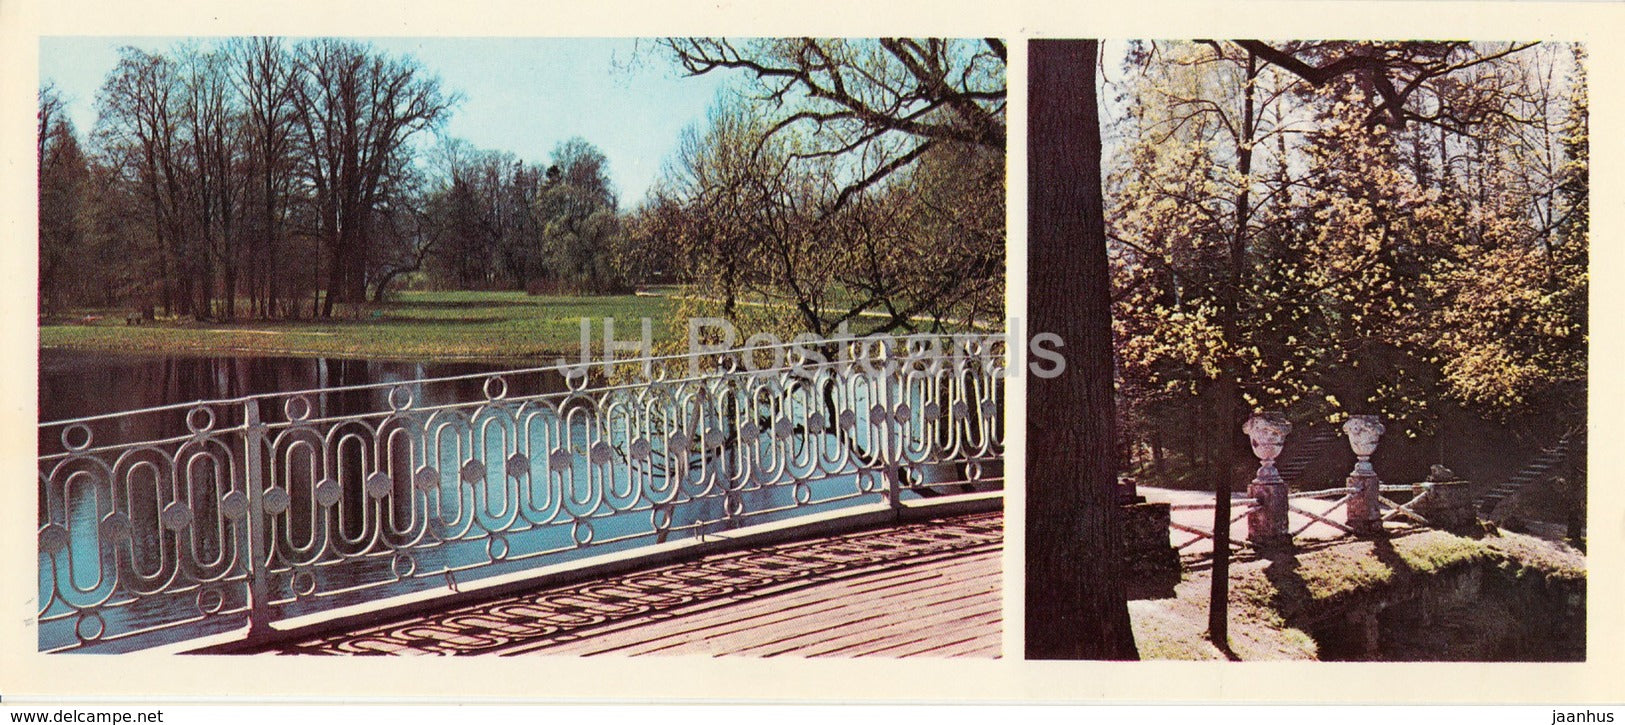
[37,37,642,319]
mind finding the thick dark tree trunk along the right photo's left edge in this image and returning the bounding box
[1027,41,1139,660]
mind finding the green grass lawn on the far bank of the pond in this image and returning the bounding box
[39,291,684,361]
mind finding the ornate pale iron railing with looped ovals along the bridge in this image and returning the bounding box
[39,335,1006,650]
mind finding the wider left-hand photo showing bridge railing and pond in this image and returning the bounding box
[37,36,1006,658]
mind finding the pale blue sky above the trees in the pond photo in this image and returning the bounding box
[39,37,728,208]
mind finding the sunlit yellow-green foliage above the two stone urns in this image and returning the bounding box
[1107,42,1588,481]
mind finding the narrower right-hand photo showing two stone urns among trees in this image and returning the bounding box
[1025,41,1589,662]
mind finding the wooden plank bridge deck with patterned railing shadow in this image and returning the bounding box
[278,514,1003,657]
